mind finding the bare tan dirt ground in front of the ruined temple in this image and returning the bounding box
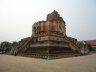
[0,54,96,72]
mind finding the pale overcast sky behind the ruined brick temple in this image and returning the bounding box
[0,0,96,42]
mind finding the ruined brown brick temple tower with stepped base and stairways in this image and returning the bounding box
[17,10,79,59]
